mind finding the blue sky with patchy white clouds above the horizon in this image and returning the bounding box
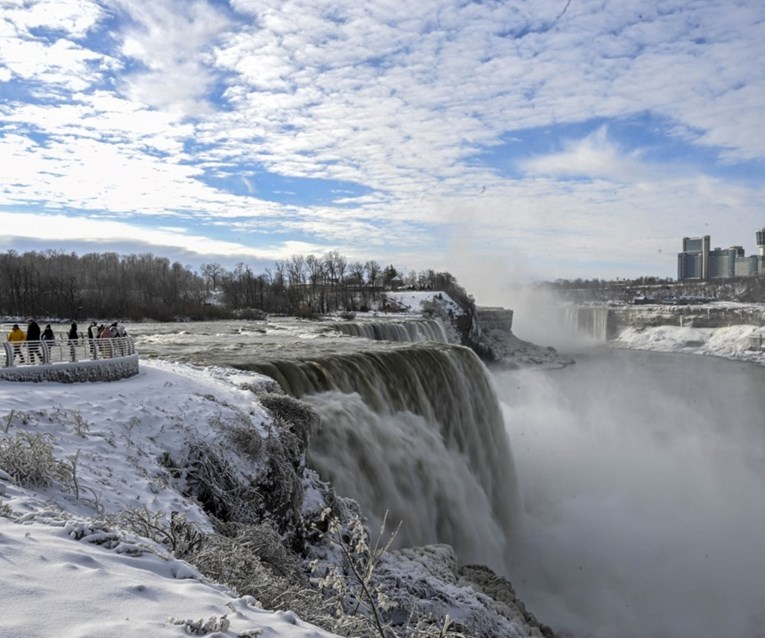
[0,0,765,288]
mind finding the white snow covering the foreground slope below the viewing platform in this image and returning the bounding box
[0,361,333,638]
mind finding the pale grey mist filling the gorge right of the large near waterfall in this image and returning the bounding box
[495,351,765,638]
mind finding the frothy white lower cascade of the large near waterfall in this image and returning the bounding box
[303,392,508,569]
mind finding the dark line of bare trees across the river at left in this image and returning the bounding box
[0,250,475,321]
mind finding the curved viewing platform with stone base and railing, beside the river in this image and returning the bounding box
[0,336,138,383]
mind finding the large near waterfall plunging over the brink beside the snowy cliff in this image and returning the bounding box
[243,344,520,570]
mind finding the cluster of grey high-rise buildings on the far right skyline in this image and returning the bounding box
[677,228,765,281]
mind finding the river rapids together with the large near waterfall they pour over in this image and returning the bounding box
[129,319,520,571]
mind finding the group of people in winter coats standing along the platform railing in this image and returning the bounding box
[7,319,127,363]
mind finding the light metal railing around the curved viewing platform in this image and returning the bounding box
[4,337,135,368]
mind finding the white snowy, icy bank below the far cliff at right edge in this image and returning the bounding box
[609,325,765,365]
